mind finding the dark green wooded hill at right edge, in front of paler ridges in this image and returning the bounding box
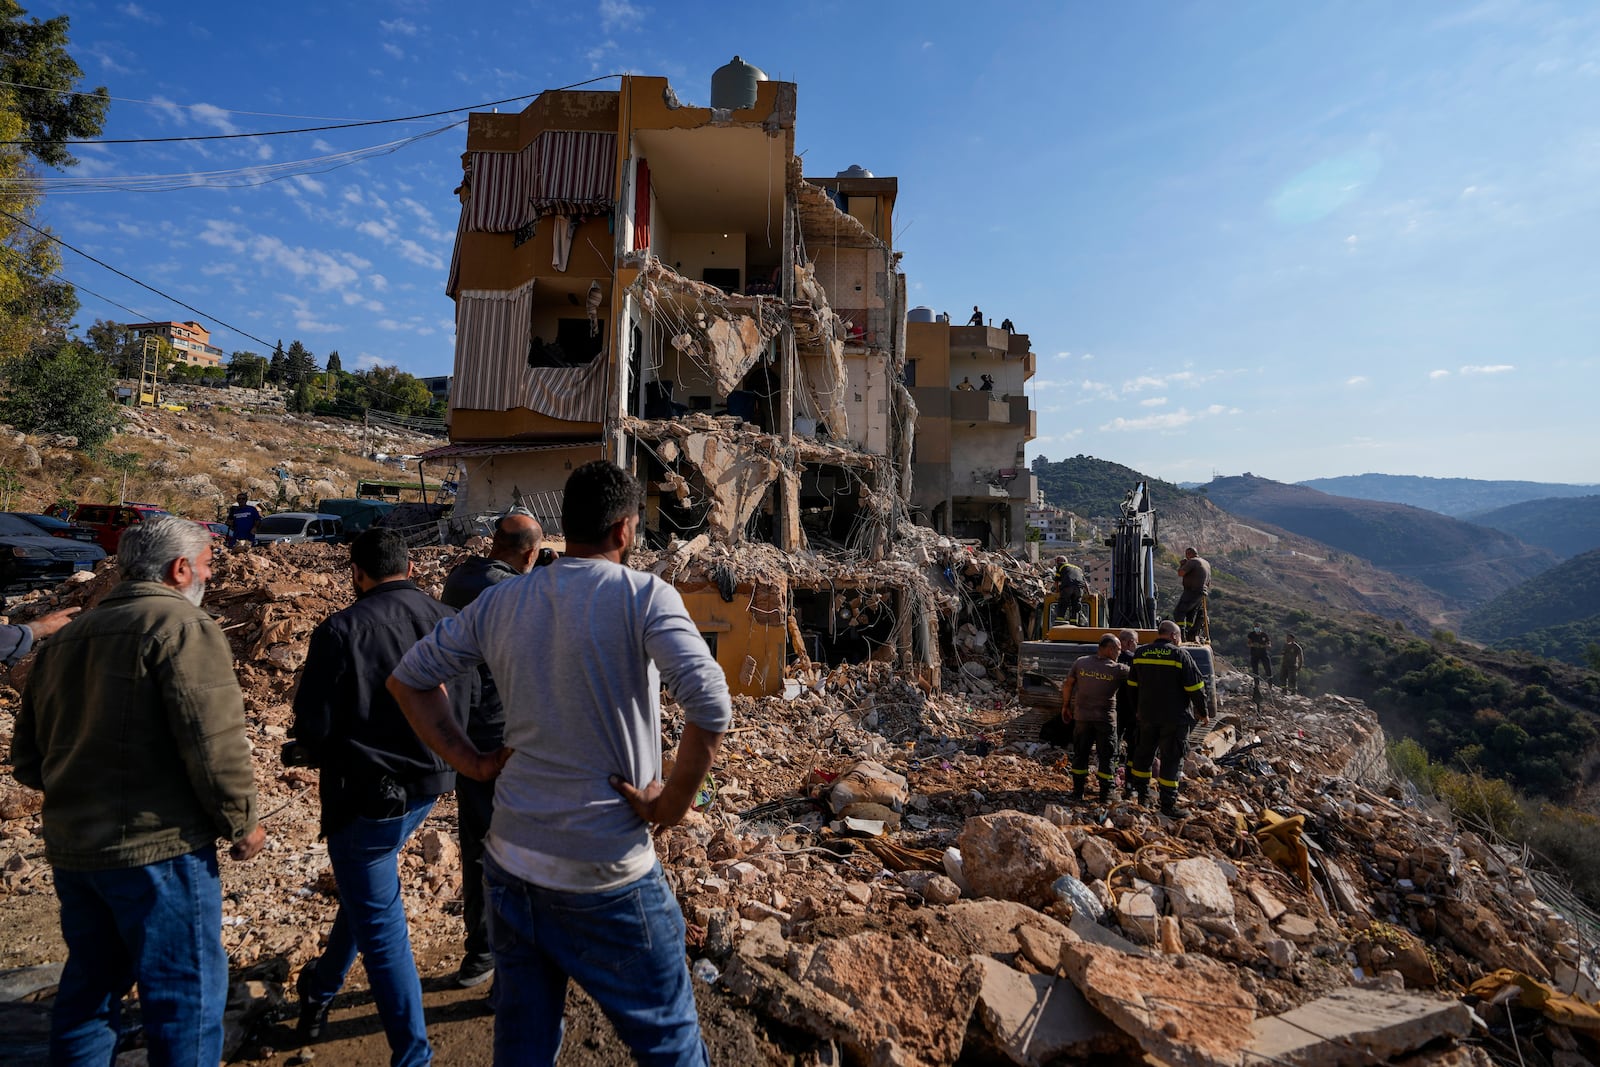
[1461,549,1600,664]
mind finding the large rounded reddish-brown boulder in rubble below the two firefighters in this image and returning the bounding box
[957,811,1078,907]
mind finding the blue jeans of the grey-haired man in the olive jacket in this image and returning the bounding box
[50,848,227,1067]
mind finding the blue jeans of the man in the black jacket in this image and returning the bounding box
[302,797,434,1067]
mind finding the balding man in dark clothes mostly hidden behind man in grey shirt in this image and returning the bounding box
[438,510,544,989]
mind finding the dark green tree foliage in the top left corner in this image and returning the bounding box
[0,0,110,166]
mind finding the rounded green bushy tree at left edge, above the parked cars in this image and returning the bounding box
[0,341,117,448]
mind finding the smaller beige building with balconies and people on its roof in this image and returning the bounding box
[906,315,1038,549]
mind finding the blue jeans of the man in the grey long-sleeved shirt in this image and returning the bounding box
[483,856,710,1067]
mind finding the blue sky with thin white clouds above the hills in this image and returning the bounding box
[29,0,1600,483]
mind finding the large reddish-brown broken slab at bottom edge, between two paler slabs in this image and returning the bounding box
[1061,937,1256,1067]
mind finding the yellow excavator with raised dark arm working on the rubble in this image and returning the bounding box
[1018,482,1216,715]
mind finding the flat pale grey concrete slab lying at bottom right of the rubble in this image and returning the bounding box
[1246,989,1472,1067]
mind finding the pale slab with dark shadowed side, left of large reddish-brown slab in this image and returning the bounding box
[973,955,1130,1067]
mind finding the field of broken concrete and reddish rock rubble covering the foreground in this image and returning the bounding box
[0,544,1600,1064]
